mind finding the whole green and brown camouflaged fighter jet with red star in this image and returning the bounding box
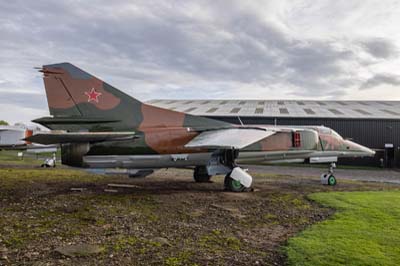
[27,63,374,192]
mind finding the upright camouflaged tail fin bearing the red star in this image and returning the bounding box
[40,63,140,117]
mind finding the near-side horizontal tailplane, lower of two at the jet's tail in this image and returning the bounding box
[25,132,136,145]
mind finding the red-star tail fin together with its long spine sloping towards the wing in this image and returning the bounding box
[38,63,231,131]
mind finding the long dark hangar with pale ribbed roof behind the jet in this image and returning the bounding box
[148,100,400,167]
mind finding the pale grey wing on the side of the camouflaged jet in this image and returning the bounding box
[185,128,275,149]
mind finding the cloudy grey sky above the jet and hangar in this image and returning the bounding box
[0,0,400,122]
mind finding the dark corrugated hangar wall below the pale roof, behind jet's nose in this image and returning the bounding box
[207,116,400,168]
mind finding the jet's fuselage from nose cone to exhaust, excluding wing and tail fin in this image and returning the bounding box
[77,125,374,168]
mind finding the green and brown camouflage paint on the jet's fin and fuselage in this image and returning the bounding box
[34,63,364,159]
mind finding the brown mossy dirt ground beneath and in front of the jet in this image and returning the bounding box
[0,166,398,265]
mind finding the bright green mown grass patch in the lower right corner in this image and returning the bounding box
[285,191,400,265]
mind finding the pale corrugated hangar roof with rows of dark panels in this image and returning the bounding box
[148,99,400,119]
